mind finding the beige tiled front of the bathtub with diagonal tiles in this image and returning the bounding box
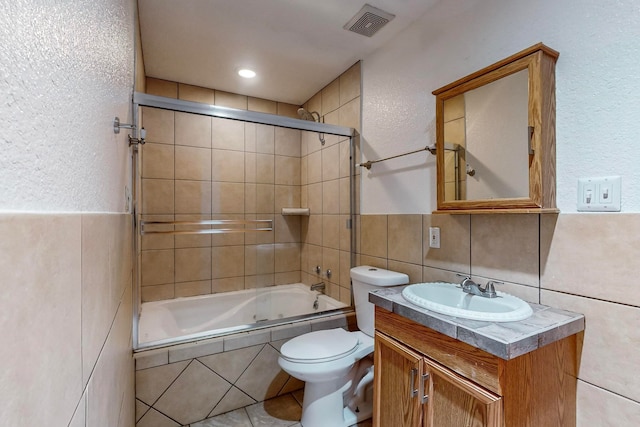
[135,313,354,427]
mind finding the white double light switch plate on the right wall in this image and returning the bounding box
[578,176,622,212]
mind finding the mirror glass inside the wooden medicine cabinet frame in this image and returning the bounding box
[444,70,529,201]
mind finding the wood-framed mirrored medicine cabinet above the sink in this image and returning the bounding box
[433,44,558,213]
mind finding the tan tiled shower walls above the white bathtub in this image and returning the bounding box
[141,63,360,304]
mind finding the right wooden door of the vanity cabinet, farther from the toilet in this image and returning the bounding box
[421,358,502,427]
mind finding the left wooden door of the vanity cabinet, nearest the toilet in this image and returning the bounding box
[373,332,424,427]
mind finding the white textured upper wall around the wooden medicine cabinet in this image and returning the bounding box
[362,0,640,213]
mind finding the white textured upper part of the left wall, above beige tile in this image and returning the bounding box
[0,0,134,212]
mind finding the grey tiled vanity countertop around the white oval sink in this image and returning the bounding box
[369,286,584,360]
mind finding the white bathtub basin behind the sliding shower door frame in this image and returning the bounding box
[138,283,348,348]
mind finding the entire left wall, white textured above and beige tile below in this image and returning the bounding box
[0,0,135,427]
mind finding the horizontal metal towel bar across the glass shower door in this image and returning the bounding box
[140,219,273,235]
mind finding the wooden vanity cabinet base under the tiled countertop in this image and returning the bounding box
[373,307,577,427]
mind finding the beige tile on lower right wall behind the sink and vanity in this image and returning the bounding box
[358,214,640,426]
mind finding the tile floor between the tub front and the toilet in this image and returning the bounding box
[185,390,372,427]
